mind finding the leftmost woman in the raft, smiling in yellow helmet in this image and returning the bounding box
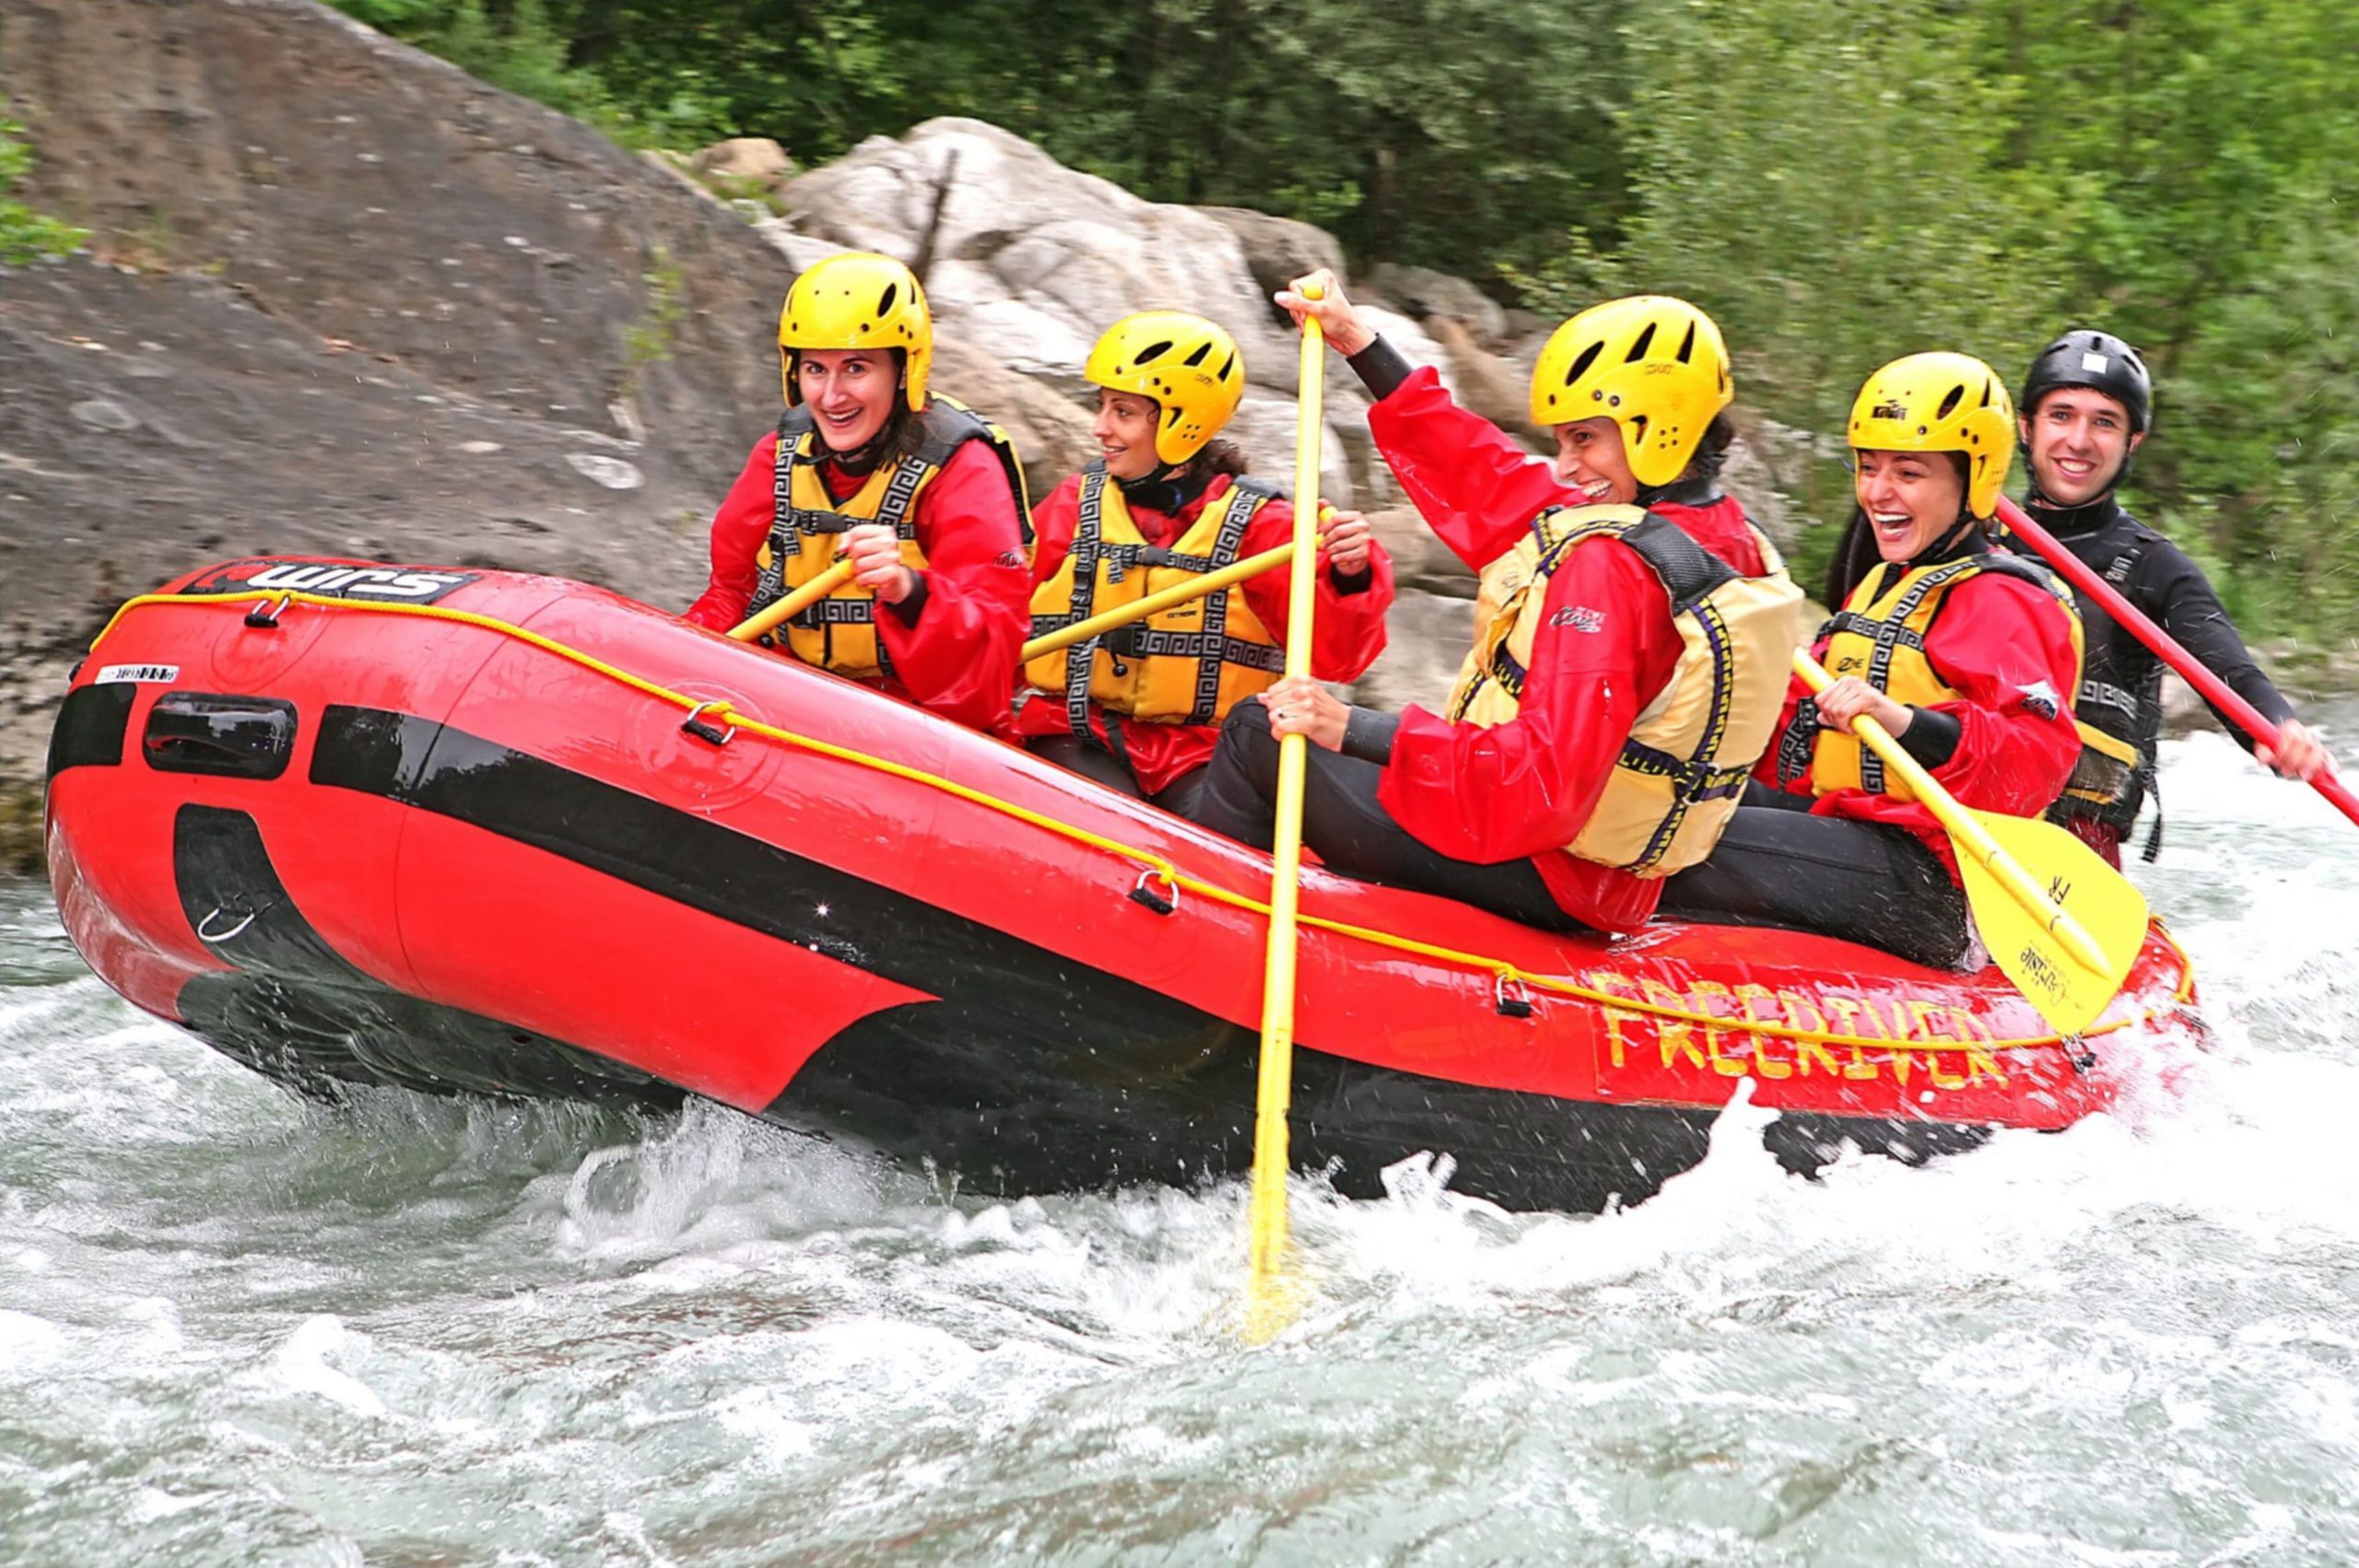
[689,252,1031,729]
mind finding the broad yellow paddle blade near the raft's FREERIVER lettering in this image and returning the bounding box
[1958,811,2147,1036]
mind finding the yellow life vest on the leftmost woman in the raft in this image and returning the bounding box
[745,392,1031,679]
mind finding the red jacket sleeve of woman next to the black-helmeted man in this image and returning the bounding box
[1911,573,2081,816]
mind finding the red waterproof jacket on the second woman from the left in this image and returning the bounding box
[1016,474,1391,795]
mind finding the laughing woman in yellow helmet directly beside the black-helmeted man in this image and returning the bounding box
[1663,354,2081,965]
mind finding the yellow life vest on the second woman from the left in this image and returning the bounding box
[1024,462,1285,736]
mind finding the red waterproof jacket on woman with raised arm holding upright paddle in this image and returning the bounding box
[1368,368,1765,931]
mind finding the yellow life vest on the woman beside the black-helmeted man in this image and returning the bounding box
[1778,552,2081,800]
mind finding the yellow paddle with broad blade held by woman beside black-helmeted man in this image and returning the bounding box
[1793,649,2147,1036]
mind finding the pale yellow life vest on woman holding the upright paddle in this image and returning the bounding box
[1449,507,1802,877]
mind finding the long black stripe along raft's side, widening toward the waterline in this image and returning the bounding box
[295,705,1979,1210]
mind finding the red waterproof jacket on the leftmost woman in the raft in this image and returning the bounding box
[687,431,1031,731]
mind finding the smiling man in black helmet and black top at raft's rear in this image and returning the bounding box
[2014,328,2326,865]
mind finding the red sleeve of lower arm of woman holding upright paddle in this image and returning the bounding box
[1378,538,1680,865]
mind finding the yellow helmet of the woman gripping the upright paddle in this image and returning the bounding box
[1531,295,1736,486]
